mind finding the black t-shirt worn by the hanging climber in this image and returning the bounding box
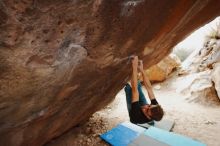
[129,99,158,124]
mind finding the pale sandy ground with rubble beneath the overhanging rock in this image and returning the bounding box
[47,75,220,146]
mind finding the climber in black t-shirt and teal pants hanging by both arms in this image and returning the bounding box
[124,56,164,124]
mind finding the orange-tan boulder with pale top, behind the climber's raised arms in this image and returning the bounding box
[145,54,181,82]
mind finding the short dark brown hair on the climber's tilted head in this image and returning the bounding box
[150,105,164,121]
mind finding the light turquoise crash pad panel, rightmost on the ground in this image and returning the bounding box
[144,127,206,146]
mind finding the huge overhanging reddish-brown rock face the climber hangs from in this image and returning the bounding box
[0,0,220,146]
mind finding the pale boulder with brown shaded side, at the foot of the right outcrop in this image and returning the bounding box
[175,69,220,106]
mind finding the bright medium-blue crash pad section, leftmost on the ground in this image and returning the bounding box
[100,124,139,146]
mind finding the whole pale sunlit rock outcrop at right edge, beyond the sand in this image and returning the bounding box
[177,39,220,104]
